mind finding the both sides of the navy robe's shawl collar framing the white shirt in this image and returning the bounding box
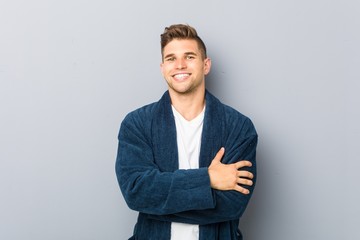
[152,91,225,172]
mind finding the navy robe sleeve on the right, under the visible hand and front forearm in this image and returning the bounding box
[149,116,258,225]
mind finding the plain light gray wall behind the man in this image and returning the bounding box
[0,0,360,240]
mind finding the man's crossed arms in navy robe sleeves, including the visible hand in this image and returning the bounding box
[116,119,257,224]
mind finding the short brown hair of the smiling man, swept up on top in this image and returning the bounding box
[160,24,207,59]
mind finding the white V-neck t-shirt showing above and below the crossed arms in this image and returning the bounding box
[171,107,205,240]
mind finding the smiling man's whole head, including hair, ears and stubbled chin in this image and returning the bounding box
[160,24,211,96]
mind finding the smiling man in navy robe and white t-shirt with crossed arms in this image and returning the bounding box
[116,24,257,240]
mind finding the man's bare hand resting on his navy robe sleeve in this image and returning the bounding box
[208,147,254,194]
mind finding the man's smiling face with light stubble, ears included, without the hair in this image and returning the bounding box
[160,39,211,95]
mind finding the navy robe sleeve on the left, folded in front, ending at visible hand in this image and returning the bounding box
[115,112,215,215]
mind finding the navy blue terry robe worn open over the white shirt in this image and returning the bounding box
[116,92,257,240]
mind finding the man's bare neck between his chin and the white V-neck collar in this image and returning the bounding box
[169,89,205,121]
